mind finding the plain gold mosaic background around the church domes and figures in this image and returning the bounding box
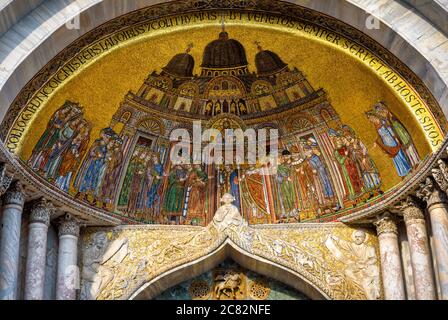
[18,22,431,190]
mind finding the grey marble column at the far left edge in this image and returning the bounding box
[0,181,25,300]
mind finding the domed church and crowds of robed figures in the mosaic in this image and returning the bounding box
[28,27,420,225]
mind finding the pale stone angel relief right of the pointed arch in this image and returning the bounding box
[325,230,381,300]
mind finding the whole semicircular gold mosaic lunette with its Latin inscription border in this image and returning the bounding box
[2,7,444,225]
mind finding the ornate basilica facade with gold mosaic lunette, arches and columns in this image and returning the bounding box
[0,0,448,300]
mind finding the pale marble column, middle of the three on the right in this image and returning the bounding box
[401,196,436,300]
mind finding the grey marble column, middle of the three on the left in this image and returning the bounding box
[25,199,52,300]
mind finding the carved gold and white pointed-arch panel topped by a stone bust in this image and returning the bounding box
[81,195,382,300]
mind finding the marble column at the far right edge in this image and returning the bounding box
[417,178,448,300]
